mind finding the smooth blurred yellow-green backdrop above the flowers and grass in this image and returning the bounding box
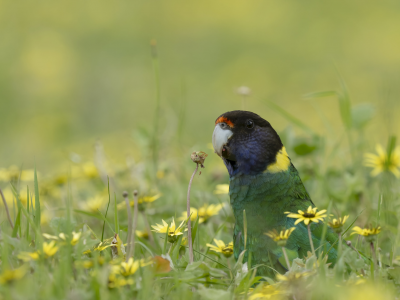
[0,0,400,170]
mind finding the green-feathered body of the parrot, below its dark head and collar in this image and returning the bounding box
[229,164,337,276]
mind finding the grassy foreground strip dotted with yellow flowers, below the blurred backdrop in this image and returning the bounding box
[0,93,400,299]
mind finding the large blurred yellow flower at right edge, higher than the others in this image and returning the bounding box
[364,144,400,178]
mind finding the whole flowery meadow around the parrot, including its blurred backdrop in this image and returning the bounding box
[0,0,400,300]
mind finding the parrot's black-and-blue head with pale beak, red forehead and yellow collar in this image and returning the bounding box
[212,110,290,177]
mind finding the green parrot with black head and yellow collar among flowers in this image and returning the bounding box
[212,110,338,276]
